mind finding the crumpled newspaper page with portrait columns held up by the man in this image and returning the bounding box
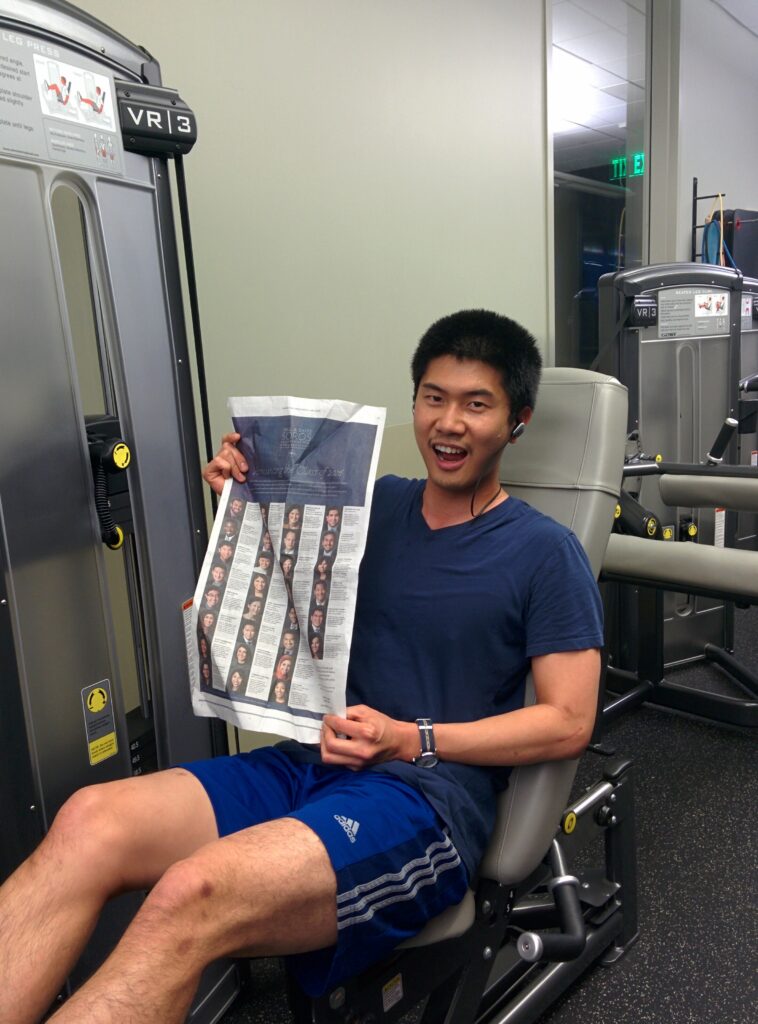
[184,397,385,742]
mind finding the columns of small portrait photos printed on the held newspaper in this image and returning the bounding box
[198,487,343,706]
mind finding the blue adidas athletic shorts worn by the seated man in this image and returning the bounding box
[181,748,468,996]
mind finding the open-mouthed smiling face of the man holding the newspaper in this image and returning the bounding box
[413,355,518,492]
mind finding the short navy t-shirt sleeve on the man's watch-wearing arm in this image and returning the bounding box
[525,532,603,657]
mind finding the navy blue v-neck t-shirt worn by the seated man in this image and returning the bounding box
[288,476,603,876]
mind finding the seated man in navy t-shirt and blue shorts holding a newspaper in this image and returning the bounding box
[0,311,602,1024]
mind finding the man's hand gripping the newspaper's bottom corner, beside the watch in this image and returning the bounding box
[321,705,419,771]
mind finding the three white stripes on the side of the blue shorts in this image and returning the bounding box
[337,835,461,929]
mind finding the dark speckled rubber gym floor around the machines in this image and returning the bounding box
[223,609,758,1024]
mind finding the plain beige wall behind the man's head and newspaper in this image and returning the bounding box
[78,0,549,436]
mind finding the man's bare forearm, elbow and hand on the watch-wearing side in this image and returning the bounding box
[322,649,600,769]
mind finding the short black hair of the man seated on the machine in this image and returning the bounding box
[411,309,542,416]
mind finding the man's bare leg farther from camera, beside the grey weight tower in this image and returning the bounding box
[0,769,218,1024]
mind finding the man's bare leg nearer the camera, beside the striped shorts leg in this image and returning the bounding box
[44,818,337,1024]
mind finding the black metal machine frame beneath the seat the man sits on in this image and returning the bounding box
[289,758,638,1024]
